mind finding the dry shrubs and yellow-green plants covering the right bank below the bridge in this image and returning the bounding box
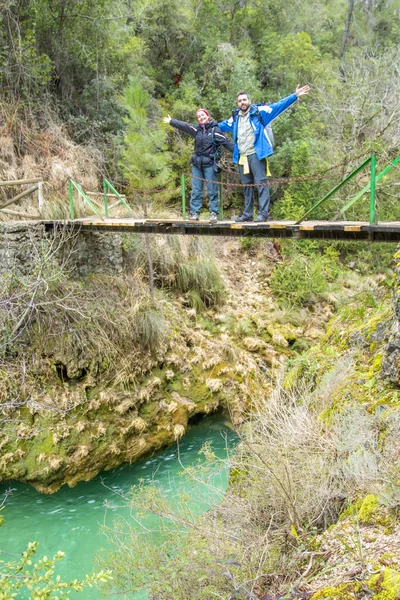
[99,237,400,600]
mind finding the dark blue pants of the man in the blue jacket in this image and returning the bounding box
[239,154,270,219]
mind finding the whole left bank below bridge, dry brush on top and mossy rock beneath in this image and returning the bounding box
[0,230,278,493]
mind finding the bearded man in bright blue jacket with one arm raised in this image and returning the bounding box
[218,85,310,222]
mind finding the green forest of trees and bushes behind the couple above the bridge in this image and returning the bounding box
[0,0,400,219]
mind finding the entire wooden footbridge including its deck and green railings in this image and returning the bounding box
[0,153,400,242]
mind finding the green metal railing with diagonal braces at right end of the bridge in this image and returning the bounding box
[296,152,400,225]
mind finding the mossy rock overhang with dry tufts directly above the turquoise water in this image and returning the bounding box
[0,327,257,493]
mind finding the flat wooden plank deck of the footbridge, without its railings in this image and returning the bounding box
[42,217,400,242]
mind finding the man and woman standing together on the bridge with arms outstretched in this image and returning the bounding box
[163,85,310,223]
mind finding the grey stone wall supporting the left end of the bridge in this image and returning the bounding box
[0,223,123,276]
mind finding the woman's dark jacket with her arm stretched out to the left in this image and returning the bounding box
[170,119,234,169]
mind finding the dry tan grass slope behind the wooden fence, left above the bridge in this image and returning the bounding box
[0,102,103,221]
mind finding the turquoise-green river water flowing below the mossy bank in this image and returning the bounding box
[0,415,236,600]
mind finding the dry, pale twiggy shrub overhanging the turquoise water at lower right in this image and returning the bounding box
[97,384,393,600]
